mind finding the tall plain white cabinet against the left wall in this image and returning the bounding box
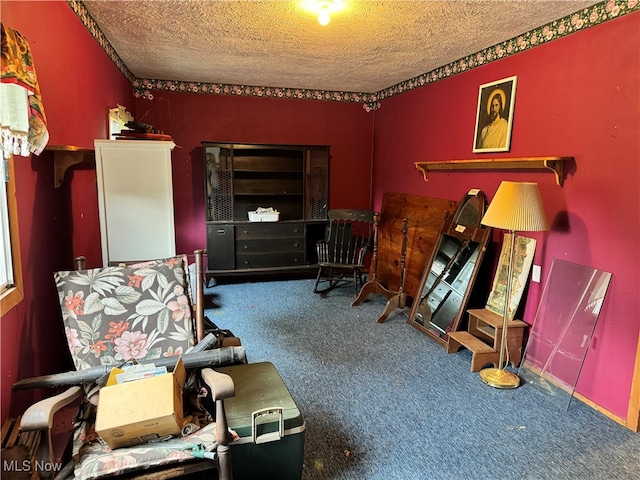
[94,140,176,266]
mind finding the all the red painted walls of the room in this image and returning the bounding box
[0,0,640,428]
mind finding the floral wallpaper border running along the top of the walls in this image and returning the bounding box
[67,0,640,112]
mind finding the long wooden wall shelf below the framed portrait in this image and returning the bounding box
[415,157,573,187]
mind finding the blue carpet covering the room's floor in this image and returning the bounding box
[206,279,640,480]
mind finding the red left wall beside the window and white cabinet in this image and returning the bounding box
[0,1,133,420]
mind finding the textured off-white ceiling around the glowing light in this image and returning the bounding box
[84,0,598,93]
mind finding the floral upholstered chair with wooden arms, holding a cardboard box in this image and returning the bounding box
[21,250,244,480]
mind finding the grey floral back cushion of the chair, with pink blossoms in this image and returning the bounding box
[54,257,194,370]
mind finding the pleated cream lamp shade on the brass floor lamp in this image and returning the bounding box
[481,181,549,232]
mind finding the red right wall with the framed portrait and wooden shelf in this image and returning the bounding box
[373,13,640,419]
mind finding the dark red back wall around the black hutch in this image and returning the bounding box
[136,92,373,252]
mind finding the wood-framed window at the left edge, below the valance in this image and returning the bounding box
[0,157,24,314]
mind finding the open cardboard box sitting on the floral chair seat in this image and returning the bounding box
[96,357,186,449]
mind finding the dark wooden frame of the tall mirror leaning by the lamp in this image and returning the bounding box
[408,189,491,347]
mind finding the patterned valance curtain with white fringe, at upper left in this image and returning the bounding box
[0,24,49,158]
